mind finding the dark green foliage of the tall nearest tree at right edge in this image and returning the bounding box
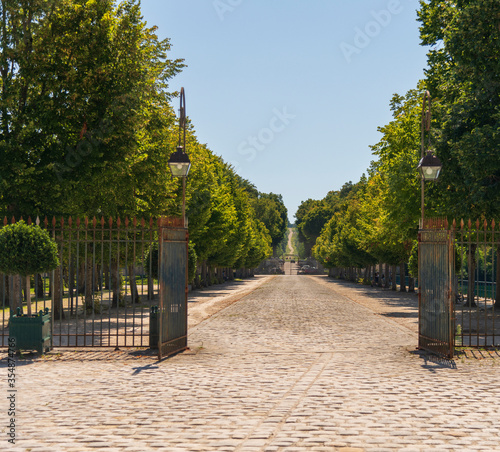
[419,0,500,218]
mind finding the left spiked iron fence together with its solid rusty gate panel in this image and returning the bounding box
[0,218,187,356]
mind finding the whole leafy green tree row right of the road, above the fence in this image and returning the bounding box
[295,0,500,298]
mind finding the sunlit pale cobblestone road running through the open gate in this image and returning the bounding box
[0,276,500,452]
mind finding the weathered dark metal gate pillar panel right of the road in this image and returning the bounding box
[418,229,455,358]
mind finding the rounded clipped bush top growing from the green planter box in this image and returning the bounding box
[0,221,59,276]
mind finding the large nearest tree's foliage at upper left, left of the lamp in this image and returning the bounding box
[0,0,182,214]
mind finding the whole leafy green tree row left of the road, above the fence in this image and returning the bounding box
[0,0,287,285]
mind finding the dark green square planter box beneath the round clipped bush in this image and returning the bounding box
[9,308,52,354]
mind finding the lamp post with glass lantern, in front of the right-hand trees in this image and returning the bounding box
[417,91,442,229]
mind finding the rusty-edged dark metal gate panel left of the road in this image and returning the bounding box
[158,219,188,359]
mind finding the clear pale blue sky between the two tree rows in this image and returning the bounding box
[142,0,427,222]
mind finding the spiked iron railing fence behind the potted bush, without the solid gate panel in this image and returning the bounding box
[0,218,160,347]
